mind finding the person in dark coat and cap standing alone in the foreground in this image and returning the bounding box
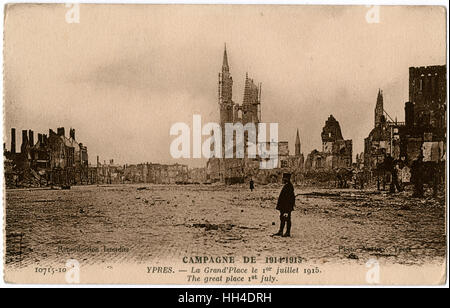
[273,173,295,237]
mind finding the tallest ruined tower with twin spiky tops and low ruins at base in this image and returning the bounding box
[206,44,304,184]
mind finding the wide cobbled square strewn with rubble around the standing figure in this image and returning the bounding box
[6,185,446,267]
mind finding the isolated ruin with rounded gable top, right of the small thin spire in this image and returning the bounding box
[305,115,353,170]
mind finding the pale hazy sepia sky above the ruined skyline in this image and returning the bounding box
[4,4,446,166]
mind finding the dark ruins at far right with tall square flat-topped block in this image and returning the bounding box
[364,65,447,171]
